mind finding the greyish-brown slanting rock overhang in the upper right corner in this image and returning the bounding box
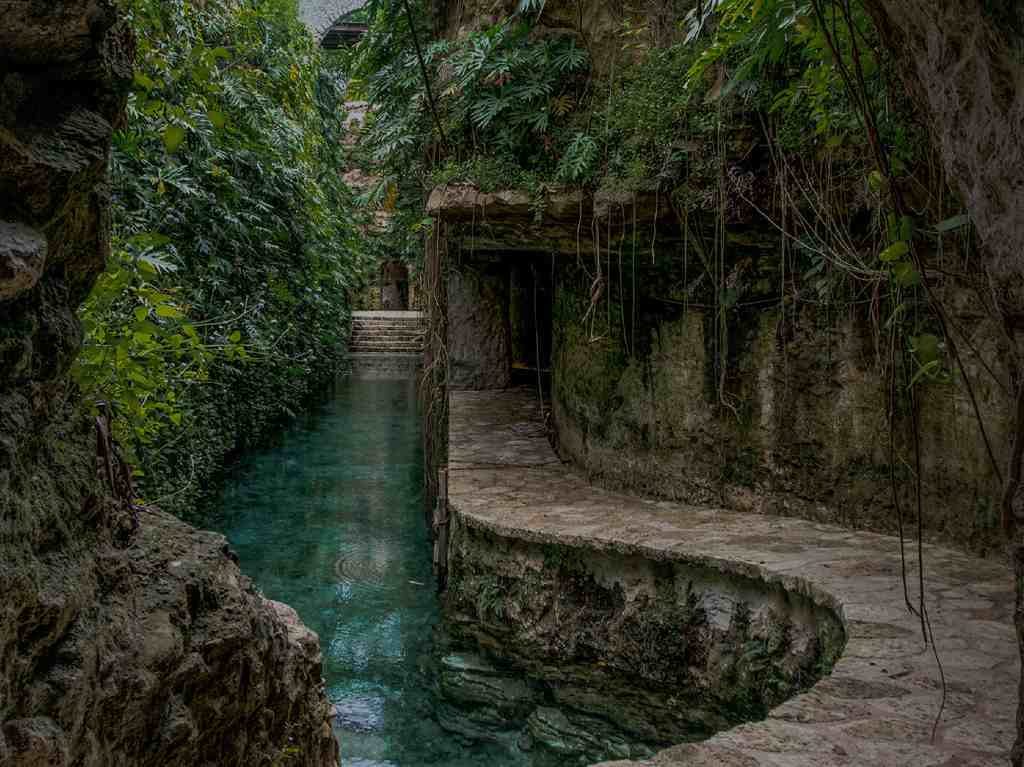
[864,0,1024,317]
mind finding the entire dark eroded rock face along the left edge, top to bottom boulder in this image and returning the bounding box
[0,0,337,767]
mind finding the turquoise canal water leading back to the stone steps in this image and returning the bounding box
[203,380,519,767]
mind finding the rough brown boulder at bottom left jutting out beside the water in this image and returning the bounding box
[3,512,337,767]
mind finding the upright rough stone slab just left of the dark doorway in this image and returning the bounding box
[447,262,512,389]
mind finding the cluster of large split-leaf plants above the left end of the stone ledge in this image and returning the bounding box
[344,0,595,267]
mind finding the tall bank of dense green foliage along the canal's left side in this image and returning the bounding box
[77,0,367,518]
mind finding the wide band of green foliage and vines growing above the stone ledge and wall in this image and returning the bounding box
[353,0,967,376]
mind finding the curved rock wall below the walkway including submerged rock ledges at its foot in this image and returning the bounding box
[437,512,845,764]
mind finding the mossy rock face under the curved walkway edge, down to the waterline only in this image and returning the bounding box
[444,525,845,744]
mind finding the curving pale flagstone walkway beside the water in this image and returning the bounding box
[450,391,1019,767]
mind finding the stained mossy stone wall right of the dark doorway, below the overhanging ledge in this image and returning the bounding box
[552,256,1010,554]
